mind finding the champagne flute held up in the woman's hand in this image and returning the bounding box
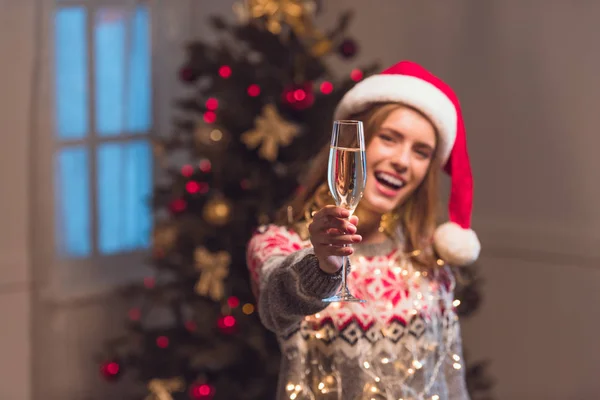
[323,120,367,303]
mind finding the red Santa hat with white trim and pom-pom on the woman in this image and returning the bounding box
[335,61,481,265]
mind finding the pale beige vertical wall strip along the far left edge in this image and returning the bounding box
[0,0,33,400]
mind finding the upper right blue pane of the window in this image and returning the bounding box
[95,7,151,136]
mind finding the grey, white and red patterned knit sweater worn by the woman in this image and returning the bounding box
[247,225,469,400]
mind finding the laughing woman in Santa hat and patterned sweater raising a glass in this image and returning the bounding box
[248,61,480,400]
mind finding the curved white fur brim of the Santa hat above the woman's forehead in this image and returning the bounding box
[334,74,457,163]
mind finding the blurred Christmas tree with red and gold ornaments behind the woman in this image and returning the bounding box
[100,0,492,400]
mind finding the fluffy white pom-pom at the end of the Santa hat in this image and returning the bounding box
[433,222,481,266]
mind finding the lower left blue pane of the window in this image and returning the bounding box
[55,147,92,257]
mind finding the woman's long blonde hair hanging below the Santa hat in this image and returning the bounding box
[278,103,441,268]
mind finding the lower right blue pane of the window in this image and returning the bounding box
[97,140,152,254]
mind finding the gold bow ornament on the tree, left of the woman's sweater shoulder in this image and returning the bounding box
[194,247,231,301]
